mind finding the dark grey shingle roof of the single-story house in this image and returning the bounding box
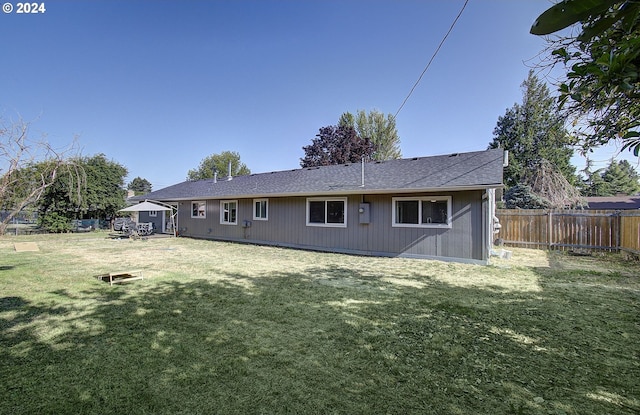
[132,149,503,200]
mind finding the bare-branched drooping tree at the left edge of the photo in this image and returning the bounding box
[0,119,80,235]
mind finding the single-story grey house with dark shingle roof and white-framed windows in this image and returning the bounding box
[133,149,505,264]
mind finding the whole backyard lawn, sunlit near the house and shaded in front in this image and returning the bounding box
[0,233,640,414]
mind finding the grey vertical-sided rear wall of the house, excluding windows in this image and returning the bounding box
[178,190,488,262]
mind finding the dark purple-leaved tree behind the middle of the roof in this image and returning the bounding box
[300,125,374,167]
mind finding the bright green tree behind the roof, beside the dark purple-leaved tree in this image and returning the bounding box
[338,110,402,160]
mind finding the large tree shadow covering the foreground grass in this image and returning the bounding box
[0,267,640,414]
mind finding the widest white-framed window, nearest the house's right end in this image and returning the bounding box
[392,196,451,228]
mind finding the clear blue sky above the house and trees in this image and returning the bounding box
[0,0,636,190]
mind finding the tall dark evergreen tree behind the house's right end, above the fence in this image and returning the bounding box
[489,71,575,188]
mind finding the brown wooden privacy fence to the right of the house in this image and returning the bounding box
[496,209,640,254]
